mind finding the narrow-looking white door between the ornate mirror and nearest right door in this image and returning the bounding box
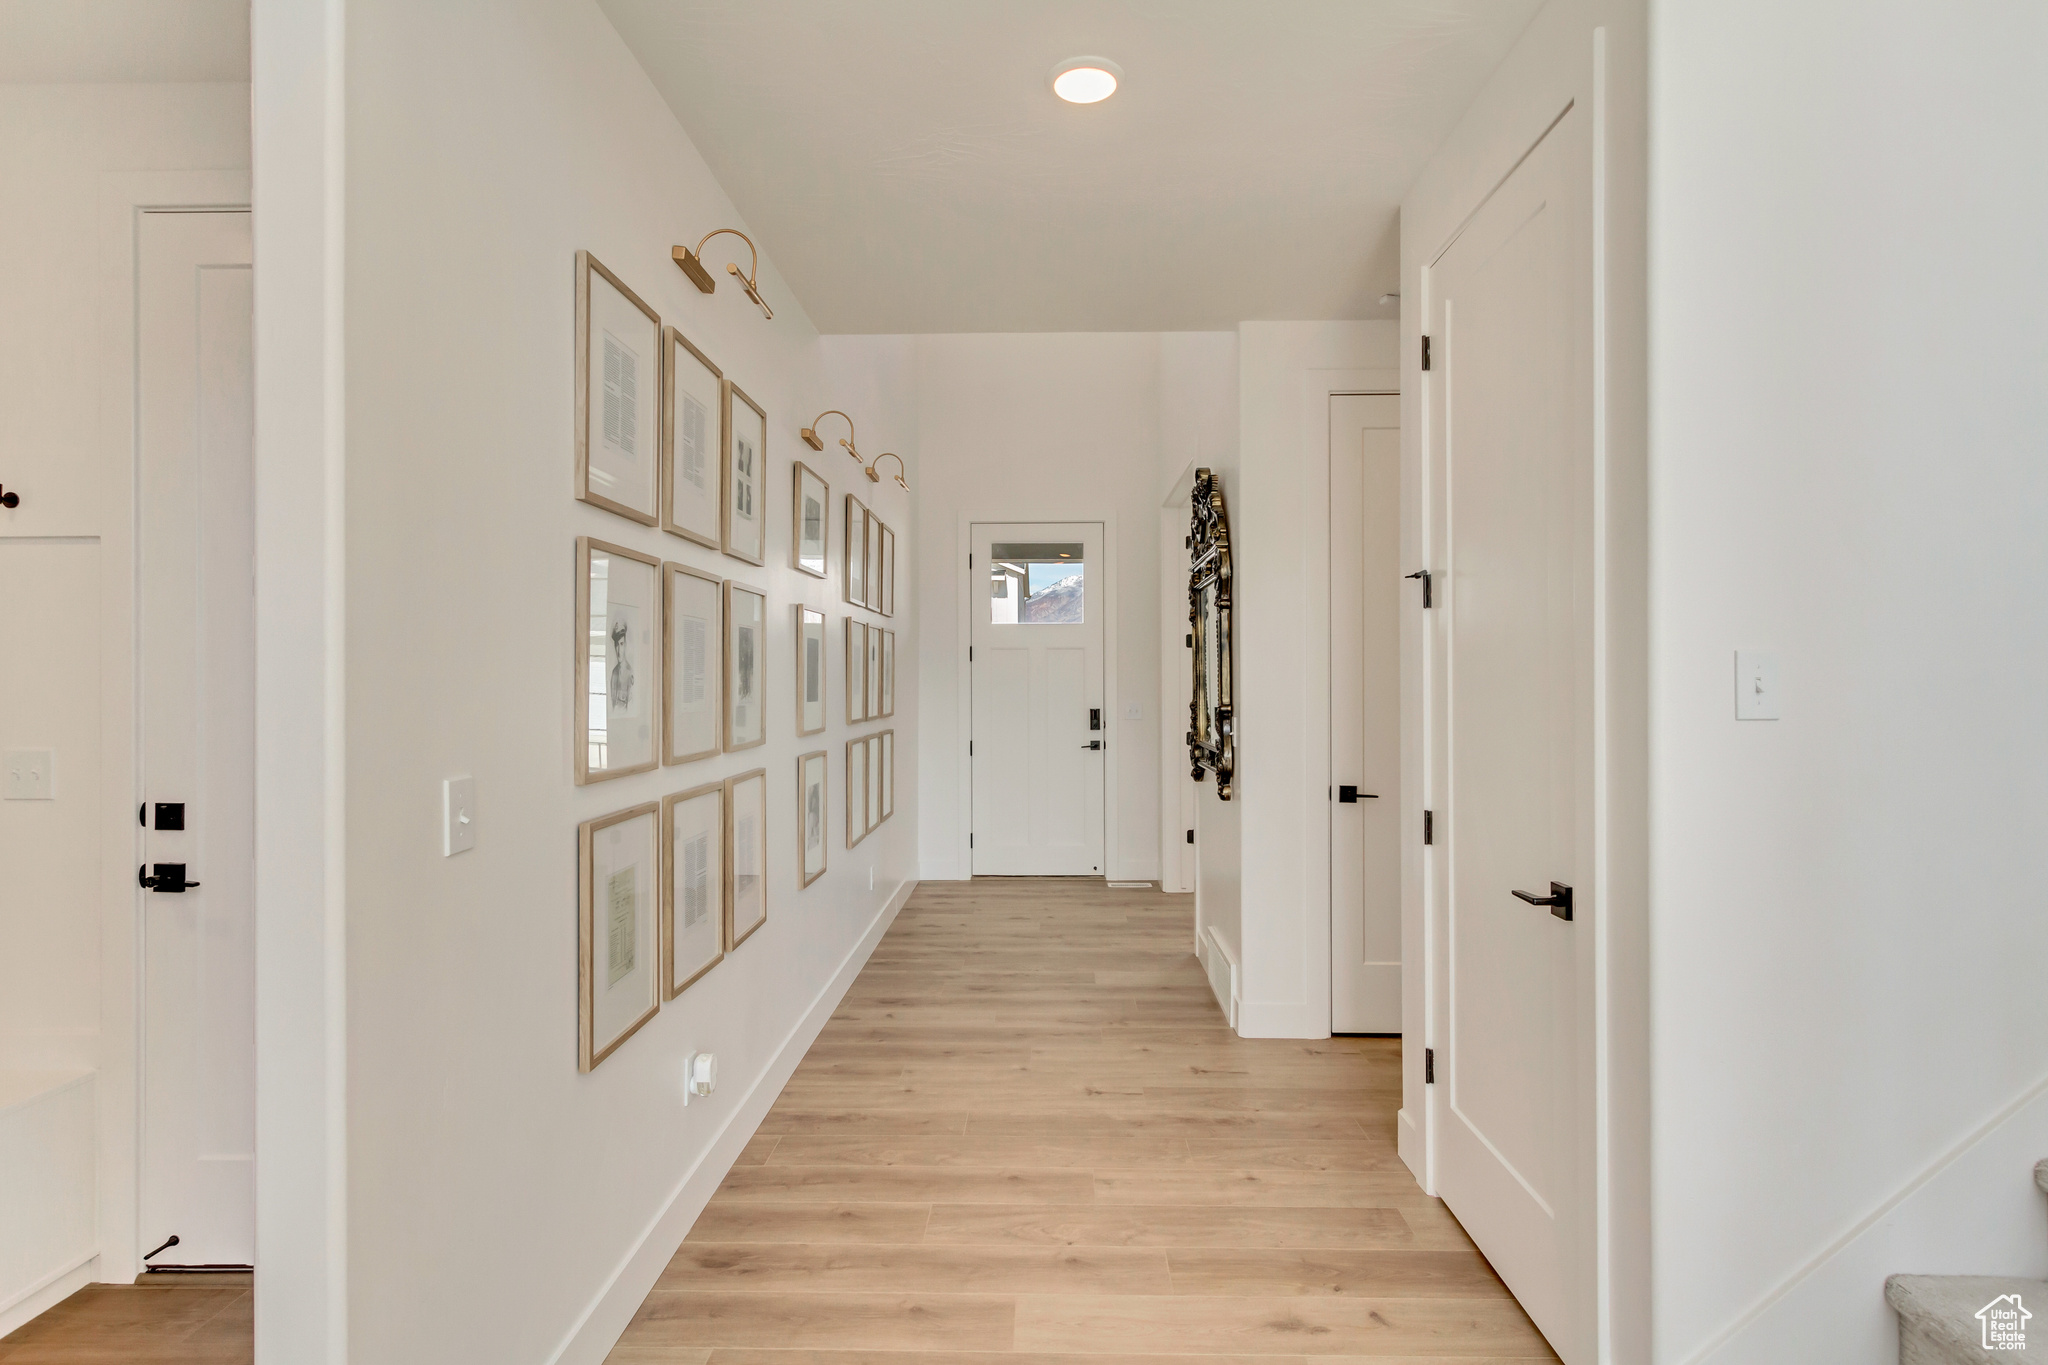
[1329,393,1401,1033]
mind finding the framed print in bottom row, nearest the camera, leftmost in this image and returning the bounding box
[575,800,662,1070]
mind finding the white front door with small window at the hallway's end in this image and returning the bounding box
[967,522,1110,876]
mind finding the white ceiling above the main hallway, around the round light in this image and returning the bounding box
[598,0,1538,332]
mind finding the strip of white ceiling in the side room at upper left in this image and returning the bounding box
[0,0,250,86]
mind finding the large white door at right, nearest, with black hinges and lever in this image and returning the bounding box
[1425,113,1599,1361]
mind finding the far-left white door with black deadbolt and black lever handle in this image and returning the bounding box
[137,213,256,1267]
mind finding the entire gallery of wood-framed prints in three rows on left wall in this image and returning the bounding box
[569,252,913,1072]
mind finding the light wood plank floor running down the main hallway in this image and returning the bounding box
[610,880,1556,1365]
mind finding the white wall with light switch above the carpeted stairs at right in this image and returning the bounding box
[1651,0,2048,1365]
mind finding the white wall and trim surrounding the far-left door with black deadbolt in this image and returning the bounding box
[0,82,250,1300]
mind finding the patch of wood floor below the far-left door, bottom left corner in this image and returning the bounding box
[0,1275,256,1365]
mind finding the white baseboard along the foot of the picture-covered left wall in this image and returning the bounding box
[547,882,918,1365]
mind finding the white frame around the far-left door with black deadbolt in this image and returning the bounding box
[90,170,250,1283]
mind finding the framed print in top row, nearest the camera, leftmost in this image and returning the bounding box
[575,252,662,526]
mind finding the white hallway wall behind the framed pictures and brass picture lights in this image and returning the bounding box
[313,0,920,1365]
